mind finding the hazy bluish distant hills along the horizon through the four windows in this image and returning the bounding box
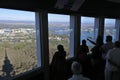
[0,20,115,27]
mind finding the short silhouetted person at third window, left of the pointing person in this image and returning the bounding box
[79,39,91,77]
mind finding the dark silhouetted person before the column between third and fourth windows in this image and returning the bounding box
[91,35,104,80]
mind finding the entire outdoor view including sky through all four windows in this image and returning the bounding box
[0,9,116,80]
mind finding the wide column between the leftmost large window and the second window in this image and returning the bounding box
[36,11,49,80]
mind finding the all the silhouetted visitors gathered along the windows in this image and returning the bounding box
[50,36,120,80]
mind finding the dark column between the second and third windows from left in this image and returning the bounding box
[70,15,81,57]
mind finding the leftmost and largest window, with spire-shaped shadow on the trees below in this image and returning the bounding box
[0,9,37,80]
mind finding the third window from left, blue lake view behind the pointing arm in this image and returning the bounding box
[81,17,95,48]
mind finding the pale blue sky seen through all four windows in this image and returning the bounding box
[0,8,115,23]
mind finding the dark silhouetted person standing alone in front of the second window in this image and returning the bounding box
[50,45,66,80]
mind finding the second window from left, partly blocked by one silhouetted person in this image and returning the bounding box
[48,14,70,62]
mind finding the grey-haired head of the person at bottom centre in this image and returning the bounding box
[71,61,82,74]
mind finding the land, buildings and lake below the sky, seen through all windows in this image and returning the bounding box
[0,21,114,79]
